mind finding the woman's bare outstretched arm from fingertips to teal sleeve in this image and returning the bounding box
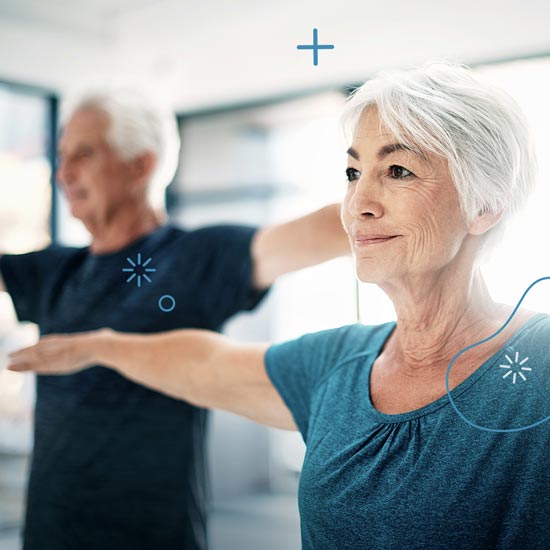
[8,329,296,430]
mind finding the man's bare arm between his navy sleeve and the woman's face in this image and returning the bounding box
[252,204,350,288]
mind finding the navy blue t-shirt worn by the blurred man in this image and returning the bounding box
[0,225,265,550]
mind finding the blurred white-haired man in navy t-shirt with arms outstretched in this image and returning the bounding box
[0,93,349,550]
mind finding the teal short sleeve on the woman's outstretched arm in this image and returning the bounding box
[265,325,374,443]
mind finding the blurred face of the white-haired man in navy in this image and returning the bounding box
[57,109,139,223]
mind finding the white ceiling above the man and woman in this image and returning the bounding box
[0,0,550,110]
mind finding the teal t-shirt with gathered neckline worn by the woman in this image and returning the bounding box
[266,314,550,550]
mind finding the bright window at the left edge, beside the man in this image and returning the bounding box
[0,85,52,452]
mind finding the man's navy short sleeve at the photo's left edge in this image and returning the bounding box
[0,246,75,324]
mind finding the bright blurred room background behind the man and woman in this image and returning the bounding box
[0,0,550,550]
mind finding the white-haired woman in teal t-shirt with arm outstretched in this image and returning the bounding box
[10,64,550,550]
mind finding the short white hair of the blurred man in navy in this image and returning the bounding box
[64,87,180,209]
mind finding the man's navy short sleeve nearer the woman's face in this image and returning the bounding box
[195,225,267,328]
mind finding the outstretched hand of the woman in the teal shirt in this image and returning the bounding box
[8,329,110,374]
